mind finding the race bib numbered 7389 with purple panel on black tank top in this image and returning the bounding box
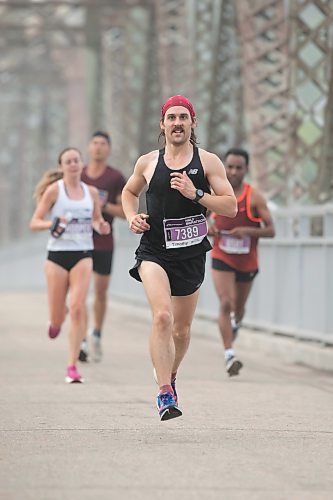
[163,214,208,249]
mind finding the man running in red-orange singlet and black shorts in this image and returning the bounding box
[210,148,275,376]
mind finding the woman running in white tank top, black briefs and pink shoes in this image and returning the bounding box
[30,148,110,383]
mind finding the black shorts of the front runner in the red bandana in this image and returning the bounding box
[129,252,206,297]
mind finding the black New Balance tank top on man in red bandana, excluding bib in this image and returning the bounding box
[140,146,211,260]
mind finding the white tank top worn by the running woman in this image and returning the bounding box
[47,179,94,252]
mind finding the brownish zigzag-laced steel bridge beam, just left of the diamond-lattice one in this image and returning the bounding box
[237,0,290,202]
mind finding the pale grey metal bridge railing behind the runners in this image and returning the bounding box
[112,204,333,344]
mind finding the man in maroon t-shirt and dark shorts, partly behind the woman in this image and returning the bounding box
[79,131,126,361]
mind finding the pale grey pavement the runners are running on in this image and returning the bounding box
[0,291,333,500]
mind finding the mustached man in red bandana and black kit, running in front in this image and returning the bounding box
[122,95,237,420]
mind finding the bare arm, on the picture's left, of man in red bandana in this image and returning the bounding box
[121,155,150,234]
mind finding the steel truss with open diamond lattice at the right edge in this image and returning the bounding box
[290,0,333,203]
